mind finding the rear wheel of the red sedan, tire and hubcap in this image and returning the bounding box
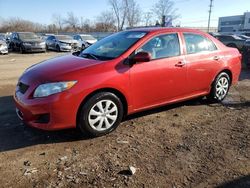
[208,72,231,102]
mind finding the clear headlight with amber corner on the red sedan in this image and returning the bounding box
[33,81,77,98]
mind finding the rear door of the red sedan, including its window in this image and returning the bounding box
[183,33,222,95]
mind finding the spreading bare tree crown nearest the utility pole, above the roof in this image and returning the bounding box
[152,0,179,24]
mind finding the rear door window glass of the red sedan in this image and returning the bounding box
[184,33,217,54]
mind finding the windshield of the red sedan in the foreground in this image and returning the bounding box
[80,31,147,60]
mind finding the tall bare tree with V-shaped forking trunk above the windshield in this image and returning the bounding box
[108,0,128,31]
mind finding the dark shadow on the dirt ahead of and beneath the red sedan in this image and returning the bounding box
[0,96,207,152]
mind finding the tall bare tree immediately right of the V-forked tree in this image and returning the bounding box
[127,0,141,27]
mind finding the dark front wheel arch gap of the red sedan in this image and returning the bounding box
[76,88,128,126]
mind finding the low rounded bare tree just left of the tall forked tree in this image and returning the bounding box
[95,11,116,32]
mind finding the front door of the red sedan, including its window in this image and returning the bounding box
[130,33,187,110]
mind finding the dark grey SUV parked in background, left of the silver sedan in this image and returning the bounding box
[9,32,46,53]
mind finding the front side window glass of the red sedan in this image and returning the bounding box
[136,33,180,60]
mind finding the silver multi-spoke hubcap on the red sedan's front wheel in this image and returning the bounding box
[88,100,118,131]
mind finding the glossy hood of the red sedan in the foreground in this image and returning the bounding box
[20,55,102,84]
